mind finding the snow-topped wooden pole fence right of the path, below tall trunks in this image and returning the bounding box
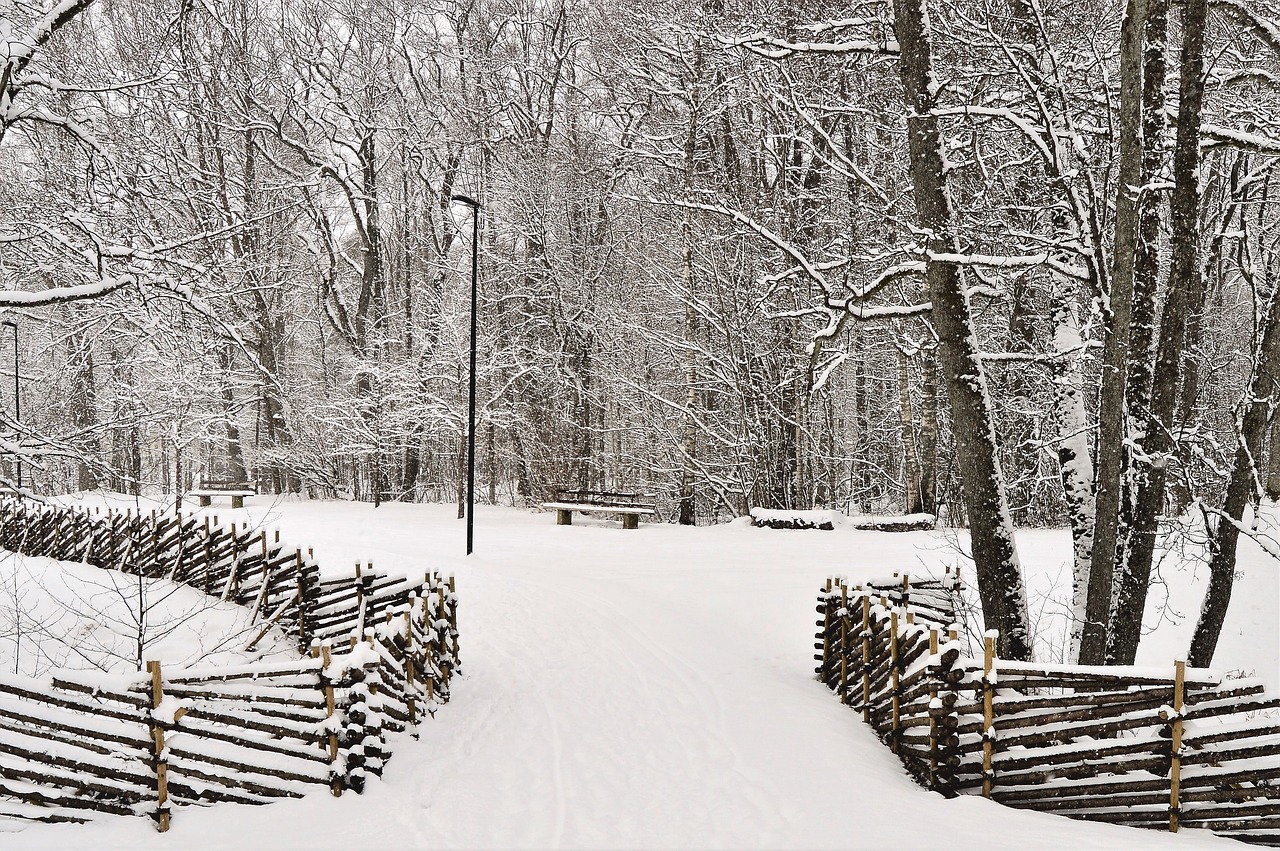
[814,577,1280,846]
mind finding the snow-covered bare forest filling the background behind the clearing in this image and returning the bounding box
[0,0,1280,665]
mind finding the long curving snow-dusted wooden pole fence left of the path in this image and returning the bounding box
[0,500,458,829]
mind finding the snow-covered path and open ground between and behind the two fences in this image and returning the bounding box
[0,498,1280,848]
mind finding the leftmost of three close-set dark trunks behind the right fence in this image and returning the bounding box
[1080,0,1147,664]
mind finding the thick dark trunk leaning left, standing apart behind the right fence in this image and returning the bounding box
[893,0,1032,659]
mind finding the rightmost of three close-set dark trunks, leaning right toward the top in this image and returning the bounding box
[1106,0,1204,664]
